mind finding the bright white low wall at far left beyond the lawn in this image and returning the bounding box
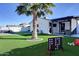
[0,26,29,32]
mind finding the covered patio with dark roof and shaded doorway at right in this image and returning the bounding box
[51,16,79,35]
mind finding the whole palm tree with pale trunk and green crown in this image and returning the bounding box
[16,3,55,39]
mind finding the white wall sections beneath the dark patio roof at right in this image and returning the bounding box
[52,18,79,34]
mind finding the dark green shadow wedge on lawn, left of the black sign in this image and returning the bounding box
[0,42,48,56]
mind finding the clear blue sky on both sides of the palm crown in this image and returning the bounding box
[0,3,79,26]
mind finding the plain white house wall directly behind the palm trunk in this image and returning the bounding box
[30,19,50,34]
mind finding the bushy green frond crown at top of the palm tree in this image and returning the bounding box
[16,3,55,17]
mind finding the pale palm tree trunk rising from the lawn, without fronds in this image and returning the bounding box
[32,11,37,39]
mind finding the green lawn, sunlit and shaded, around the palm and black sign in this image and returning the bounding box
[0,35,79,56]
